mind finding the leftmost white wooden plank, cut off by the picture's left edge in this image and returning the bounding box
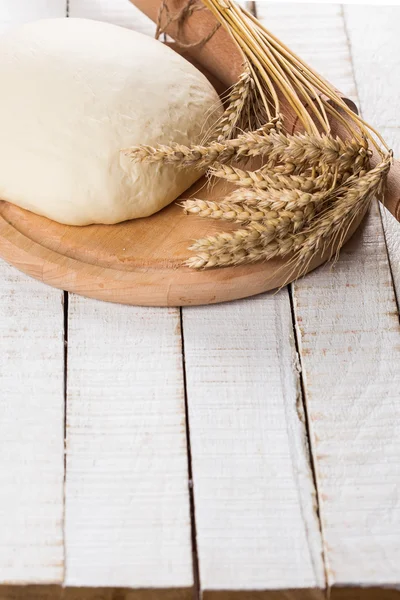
[0,0,66,589]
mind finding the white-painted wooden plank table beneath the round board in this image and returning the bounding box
[0,0,400,600]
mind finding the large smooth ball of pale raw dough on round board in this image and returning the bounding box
[0,19,222,225]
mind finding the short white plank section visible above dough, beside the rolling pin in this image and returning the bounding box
[68,0,155,35]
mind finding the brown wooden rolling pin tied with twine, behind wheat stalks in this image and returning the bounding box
[131,0,400,221]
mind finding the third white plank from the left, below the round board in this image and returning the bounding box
[183,290,324,598]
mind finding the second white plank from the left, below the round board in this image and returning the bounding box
[65,295,193,589]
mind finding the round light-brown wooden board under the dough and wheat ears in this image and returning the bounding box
[0,179,366,306]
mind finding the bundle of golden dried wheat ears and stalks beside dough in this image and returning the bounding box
[125,0,393,276]
